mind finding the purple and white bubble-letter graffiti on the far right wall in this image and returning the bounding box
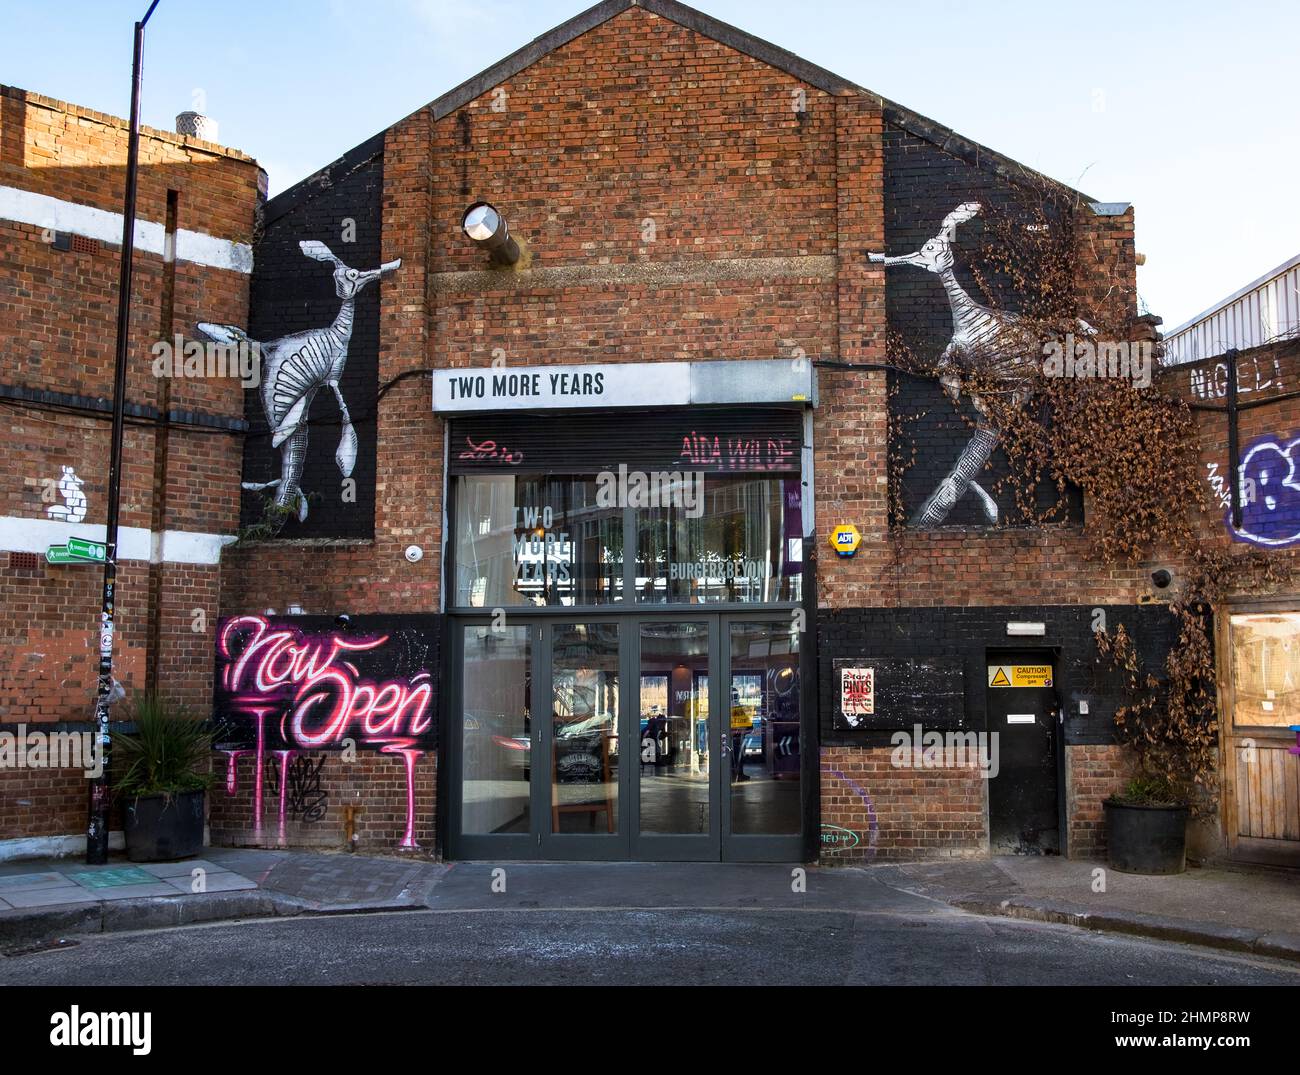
[1209,433,1300,549]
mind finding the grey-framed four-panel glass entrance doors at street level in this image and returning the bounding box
[449,612,805,862]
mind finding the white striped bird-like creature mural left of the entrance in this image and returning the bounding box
[199,239,402,524]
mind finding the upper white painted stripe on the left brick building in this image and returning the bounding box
[0,186,252,273]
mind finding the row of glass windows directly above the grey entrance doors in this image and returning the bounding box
[452,472,803,608]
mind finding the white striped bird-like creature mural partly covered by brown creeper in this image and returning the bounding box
[867,201,1096,528]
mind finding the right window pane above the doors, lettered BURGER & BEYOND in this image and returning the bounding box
[636,474,803,604]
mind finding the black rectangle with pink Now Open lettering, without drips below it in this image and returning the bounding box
[213,615,438,751]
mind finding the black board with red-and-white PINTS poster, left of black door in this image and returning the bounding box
[832,656,966,733]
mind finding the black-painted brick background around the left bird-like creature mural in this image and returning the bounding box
[242,152,384,538]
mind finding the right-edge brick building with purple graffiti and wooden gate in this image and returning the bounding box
[1161,321,1300,866]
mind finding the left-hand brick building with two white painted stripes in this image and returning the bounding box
[0,86,265,853]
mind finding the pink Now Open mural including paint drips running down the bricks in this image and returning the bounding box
[215,615,437,848]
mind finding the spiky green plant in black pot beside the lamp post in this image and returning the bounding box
[113,693,215,862]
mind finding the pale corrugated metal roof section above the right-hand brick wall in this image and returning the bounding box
[1165,253,1300,365]
